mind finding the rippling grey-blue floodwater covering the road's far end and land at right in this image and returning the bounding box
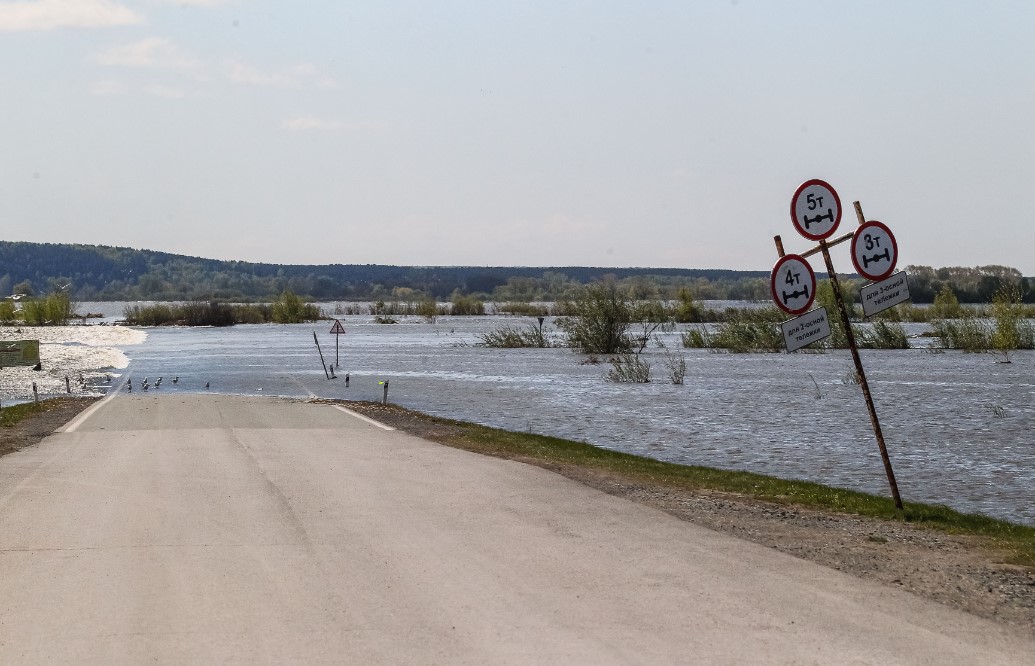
[91,316,1035,525]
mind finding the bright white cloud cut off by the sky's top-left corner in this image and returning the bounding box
[0,0,144,31]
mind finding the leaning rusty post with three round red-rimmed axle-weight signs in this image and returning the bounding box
[771,179,905,509]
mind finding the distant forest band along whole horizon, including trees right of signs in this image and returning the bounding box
[0,241,1035,302]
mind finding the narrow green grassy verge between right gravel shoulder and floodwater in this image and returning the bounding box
[356,405,1035,567]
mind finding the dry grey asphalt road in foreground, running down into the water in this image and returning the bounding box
[0,395,1035,665]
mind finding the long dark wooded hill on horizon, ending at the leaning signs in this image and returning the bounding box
[0,241,769,300]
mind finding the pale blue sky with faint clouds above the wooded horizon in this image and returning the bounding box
[0,0,1035,276]
